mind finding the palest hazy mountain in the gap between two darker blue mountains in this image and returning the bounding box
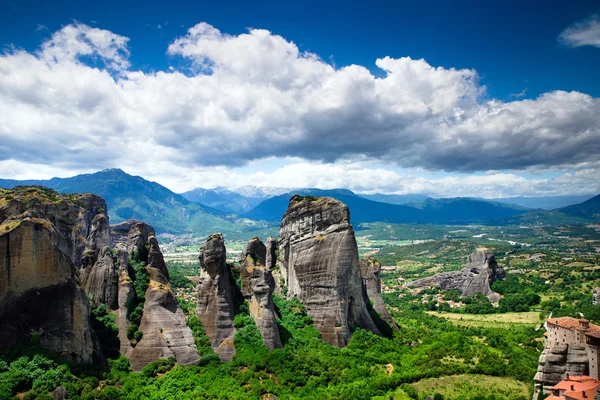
[181,186,290,214]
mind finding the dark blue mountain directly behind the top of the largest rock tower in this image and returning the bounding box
[243,189,525,224]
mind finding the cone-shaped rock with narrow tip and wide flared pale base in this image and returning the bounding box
[129,236,200,371]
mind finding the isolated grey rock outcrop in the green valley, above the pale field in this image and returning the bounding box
[406,248,506,301]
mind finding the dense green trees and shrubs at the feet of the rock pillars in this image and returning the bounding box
[0,290,540,400]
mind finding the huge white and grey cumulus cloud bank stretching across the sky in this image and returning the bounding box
[0,23,600,196]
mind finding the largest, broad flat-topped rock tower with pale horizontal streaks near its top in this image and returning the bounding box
[278,195,380,347]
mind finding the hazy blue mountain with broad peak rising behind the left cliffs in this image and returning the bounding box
[0,169,255,233]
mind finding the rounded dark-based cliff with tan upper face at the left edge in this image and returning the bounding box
[0,216,106,365]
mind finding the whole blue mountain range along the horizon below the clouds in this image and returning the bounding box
[0,169,600,236]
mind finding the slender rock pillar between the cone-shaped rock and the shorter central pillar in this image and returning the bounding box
[196,233,241,361]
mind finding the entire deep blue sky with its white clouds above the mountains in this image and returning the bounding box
[0,0,600,198]
